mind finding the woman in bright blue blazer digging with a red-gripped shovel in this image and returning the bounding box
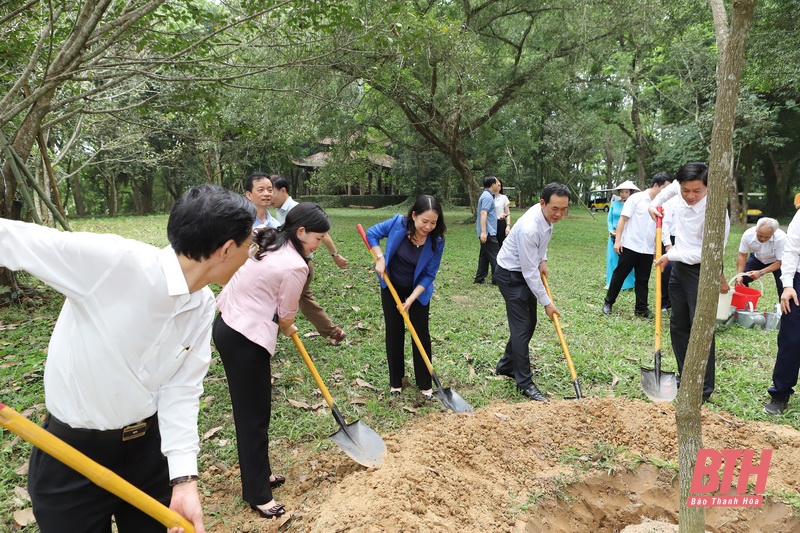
[367,194,447,399]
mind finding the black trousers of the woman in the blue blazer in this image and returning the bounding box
[381,286,433,390]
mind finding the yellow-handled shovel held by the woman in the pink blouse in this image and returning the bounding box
[292,332,386,466]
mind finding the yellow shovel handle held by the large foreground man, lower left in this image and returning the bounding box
[0,403,194,533]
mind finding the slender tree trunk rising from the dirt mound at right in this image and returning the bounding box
[675,4,755,533]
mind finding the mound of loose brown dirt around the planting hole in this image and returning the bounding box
[198,398,800,533]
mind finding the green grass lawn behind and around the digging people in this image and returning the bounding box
[0,206,800,531]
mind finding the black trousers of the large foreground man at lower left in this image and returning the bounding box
[28,416,172,533]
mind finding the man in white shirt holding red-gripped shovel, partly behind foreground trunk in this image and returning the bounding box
[650,163,730,402]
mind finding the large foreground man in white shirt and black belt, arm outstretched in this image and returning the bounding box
[0,185,255,533]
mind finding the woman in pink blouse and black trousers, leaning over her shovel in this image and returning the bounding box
[213,202,331,518]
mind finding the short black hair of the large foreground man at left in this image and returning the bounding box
[167,184,256,261]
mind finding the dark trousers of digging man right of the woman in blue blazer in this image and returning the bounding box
[496,266,538,390]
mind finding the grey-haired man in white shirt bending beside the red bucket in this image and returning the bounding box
[736,217,786,298]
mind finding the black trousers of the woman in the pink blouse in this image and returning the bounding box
[214,315,272,504]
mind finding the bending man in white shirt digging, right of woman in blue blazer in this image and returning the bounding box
[495,183,570,402]
